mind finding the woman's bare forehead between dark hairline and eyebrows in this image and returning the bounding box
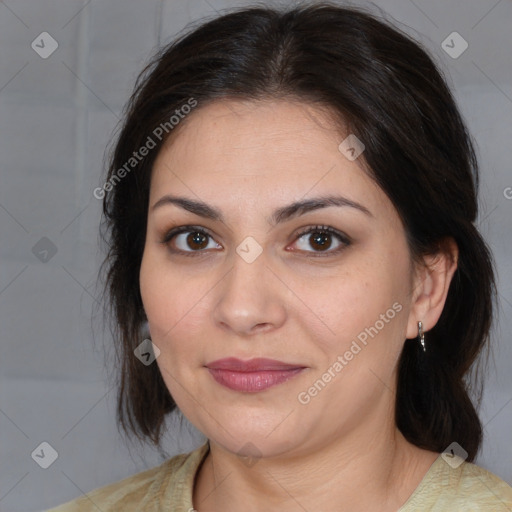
[151,100,385,215]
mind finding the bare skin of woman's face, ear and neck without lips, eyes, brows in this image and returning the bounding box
[140,100,457,512]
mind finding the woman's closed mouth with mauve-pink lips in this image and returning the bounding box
[205,358,306,393]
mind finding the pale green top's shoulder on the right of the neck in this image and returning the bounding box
[399,455,512,512]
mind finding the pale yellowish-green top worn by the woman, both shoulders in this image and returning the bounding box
[49,442,512,512]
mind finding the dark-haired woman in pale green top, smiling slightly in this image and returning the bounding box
[49,4,512,512]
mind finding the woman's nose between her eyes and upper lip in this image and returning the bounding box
[213,253,286,336]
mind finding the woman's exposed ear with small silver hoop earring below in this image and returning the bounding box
[406,237,459,339]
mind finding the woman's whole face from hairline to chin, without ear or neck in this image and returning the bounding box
[140,100,412,456]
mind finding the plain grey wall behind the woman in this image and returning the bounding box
[0,0,512,511]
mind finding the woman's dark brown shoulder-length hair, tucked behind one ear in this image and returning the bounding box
[100,3,495,461]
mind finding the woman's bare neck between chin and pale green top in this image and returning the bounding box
[194,416,438,512]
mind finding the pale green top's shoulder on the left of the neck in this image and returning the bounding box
[47,443,209,512]
